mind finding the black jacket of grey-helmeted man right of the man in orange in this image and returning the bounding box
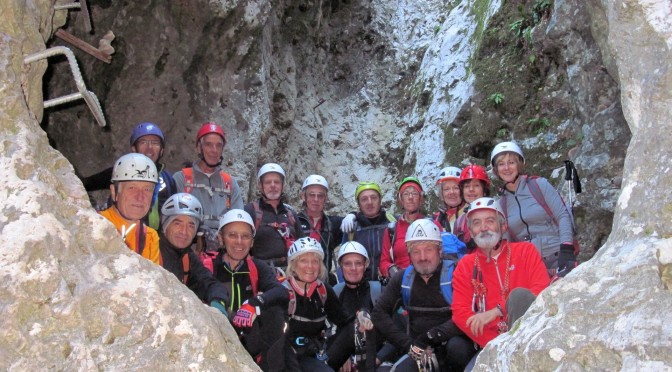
[159,232,229,304]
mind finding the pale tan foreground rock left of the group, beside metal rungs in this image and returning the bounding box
[0,0,257,371]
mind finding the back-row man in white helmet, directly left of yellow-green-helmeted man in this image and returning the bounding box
[298,174,343,285]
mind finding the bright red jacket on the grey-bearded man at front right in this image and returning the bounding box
[453,240,550,347]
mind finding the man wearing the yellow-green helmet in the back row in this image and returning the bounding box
[341,181,396,280]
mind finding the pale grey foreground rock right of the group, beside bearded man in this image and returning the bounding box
[477,0,672,371]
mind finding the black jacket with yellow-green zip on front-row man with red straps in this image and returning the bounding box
[213,250,289,314]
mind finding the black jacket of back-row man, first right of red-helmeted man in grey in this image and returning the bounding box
[245,198,304,266]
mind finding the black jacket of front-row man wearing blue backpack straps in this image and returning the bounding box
[371,264,464,350]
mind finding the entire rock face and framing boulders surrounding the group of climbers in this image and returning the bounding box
[0,0,672,371]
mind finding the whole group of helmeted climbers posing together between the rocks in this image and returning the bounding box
[83,122,577,372]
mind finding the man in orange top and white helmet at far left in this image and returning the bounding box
[100,153,161,265]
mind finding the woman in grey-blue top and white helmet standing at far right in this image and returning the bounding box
[490,142,577,276]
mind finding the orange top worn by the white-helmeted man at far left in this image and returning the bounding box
[100,207,161,265]
